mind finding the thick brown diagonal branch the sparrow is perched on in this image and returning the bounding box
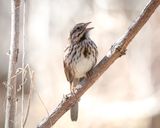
[37,0,160,128]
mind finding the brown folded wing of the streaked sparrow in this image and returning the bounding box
[63,60,74,83]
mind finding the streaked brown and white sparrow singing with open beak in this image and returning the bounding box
[63,22,98,121]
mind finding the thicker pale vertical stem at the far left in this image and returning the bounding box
[5,0,20,128]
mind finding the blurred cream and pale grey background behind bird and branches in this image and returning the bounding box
[0,0,160,128]
